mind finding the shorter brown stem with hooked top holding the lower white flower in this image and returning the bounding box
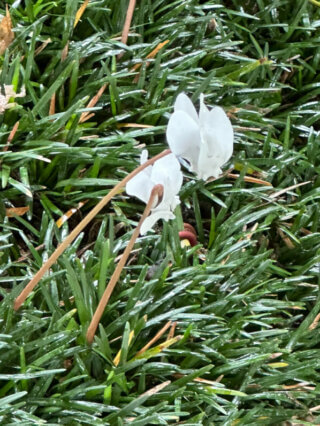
[86,185,163,343]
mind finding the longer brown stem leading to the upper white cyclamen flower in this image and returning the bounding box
[14,149,171,311]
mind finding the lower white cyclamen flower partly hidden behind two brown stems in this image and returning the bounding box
[126,150,182,235]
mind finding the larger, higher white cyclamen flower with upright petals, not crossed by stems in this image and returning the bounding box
[167,93,233,180]
